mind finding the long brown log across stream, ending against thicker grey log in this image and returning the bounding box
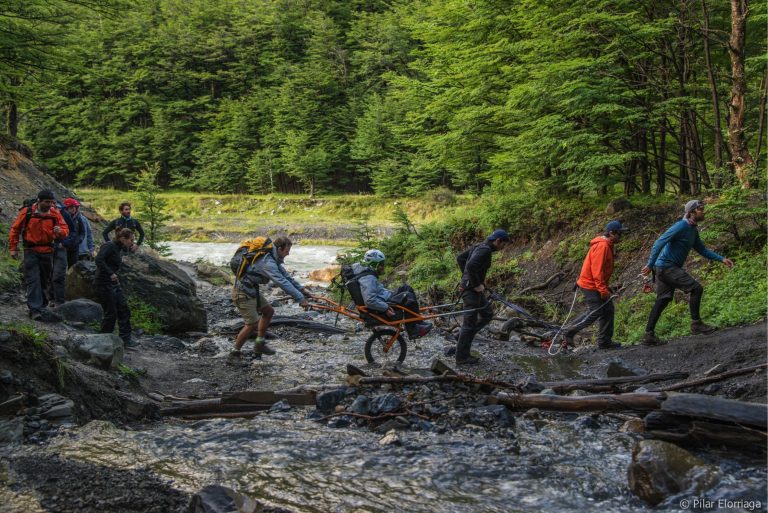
[489,392,664,412]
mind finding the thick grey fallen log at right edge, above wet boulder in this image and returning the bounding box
[661,392,768,430]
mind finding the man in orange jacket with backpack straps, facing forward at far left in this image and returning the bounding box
[8,191,69,320]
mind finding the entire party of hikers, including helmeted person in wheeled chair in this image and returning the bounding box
[9,190,734,365]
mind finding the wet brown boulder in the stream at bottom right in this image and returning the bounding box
[628,440,720,506]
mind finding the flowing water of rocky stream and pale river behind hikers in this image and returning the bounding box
[0,243,767,513]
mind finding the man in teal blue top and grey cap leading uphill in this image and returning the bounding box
[642,200,733,346]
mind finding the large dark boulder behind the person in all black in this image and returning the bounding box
[66,253,208,333]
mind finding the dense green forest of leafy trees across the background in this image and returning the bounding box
[0,0,766,196]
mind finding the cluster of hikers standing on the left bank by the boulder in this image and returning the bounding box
[8,190,144,347]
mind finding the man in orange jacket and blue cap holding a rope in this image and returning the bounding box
[565,221,628,349]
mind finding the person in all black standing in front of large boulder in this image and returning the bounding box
[94,228,136,347]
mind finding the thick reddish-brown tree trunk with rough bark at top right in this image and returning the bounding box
[728,0,754,188]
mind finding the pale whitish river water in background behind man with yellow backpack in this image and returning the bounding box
[167,242,344,278]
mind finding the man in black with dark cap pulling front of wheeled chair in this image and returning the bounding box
[456,230,509,365]
